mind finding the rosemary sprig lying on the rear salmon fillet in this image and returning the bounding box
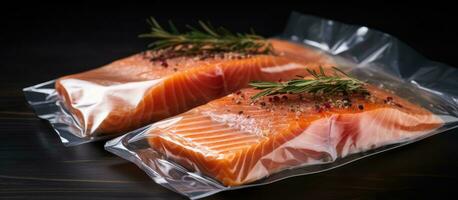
[139,17,273,57]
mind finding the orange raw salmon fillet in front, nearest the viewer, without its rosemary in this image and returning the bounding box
[145,86,443,186]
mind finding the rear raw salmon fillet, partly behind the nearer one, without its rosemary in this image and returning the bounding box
[55,40,333,137]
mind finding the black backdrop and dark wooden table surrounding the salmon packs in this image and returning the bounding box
[0,1,458,199]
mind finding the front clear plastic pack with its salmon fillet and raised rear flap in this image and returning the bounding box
[105,13,458,199]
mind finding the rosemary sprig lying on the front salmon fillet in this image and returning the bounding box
[249,67,369,100]
